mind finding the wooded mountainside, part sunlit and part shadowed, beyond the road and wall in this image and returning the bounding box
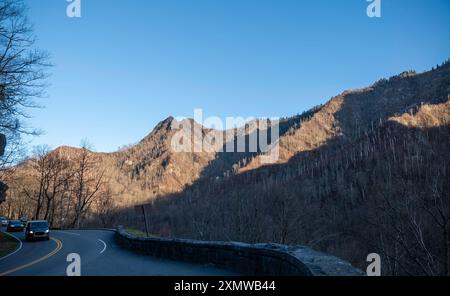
[1,62,450,275]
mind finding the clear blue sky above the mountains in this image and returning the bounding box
[25,0,450,151]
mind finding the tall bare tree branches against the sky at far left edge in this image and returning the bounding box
[0,0,50,202]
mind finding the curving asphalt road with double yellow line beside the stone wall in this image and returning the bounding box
[0,229,239,276]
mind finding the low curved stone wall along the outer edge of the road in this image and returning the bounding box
[116,227,364,276]
